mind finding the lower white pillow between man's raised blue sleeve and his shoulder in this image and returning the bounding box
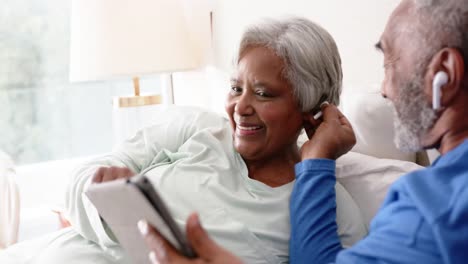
[336,152,423,228]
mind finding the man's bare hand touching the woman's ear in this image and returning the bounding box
[301,104,356,160]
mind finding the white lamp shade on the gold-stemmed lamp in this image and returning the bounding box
[70,0,204,82]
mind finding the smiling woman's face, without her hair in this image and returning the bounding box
[226,46,303,161]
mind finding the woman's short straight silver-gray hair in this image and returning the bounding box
[236,17,343,111]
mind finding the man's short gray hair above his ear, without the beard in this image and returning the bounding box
[412,0,468,70]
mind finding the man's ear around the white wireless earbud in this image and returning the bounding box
[425,48,465,107]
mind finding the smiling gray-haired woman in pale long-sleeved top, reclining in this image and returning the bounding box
[0,18,365,263]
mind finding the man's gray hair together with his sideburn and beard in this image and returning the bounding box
[394,0,468,151]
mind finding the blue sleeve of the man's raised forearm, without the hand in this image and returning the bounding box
[289,159,342,264]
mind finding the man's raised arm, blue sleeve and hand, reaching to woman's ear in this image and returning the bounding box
[289,103,356,264]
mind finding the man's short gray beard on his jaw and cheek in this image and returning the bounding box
[393,74,437,152]
